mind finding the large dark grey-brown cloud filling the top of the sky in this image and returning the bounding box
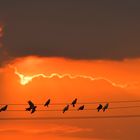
[0,0,140,65]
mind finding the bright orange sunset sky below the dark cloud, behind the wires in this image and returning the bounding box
[0,56,140,140]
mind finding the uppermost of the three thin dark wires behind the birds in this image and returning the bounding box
[0,100,140,105]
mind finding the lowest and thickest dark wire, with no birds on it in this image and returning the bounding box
[0,114,140,121]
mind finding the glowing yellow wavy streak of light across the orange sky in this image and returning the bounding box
[14,68,128,88]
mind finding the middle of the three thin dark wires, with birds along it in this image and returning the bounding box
[7,106,140,112]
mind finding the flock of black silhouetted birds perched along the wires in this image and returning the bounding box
[0,98,109,114]
